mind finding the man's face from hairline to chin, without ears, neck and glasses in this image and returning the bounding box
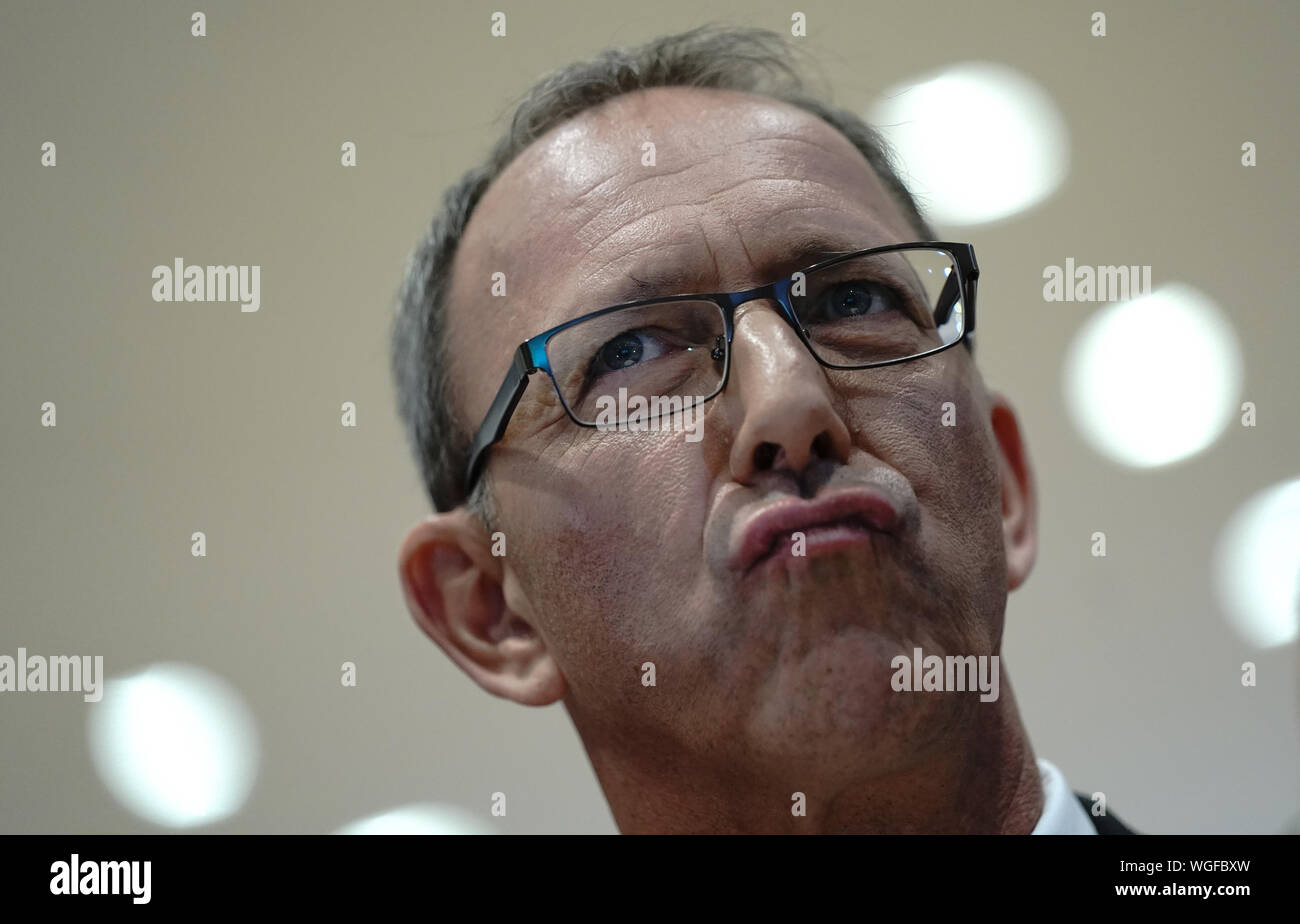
[449,88,1008,772]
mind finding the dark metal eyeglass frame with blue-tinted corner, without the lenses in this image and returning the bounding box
[464,240,979,498]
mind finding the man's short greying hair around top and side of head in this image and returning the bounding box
[391,26,936,512]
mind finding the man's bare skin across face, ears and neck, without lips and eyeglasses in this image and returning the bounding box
[399,87,1043,833]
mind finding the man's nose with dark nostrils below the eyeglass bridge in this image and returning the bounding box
[727,303,853,485]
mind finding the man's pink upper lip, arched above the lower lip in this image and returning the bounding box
[731,486,900,573]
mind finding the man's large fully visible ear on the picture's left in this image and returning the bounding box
[398,507,566,706]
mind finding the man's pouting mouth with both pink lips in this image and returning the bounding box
[731,487,900,574]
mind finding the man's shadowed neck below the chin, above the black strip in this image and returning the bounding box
[569,674,1043,834]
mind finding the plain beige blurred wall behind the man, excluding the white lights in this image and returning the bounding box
[0,0,1300,833]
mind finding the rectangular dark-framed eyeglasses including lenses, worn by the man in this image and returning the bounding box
[465,242,979,496]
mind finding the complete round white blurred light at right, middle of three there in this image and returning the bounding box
[1063,285,1242,468]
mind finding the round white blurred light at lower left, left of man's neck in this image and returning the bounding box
[87,663,257,828]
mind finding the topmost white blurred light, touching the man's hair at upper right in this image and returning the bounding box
[867,61,1070,225]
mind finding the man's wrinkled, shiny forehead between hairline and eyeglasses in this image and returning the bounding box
[447,87,915,424]
